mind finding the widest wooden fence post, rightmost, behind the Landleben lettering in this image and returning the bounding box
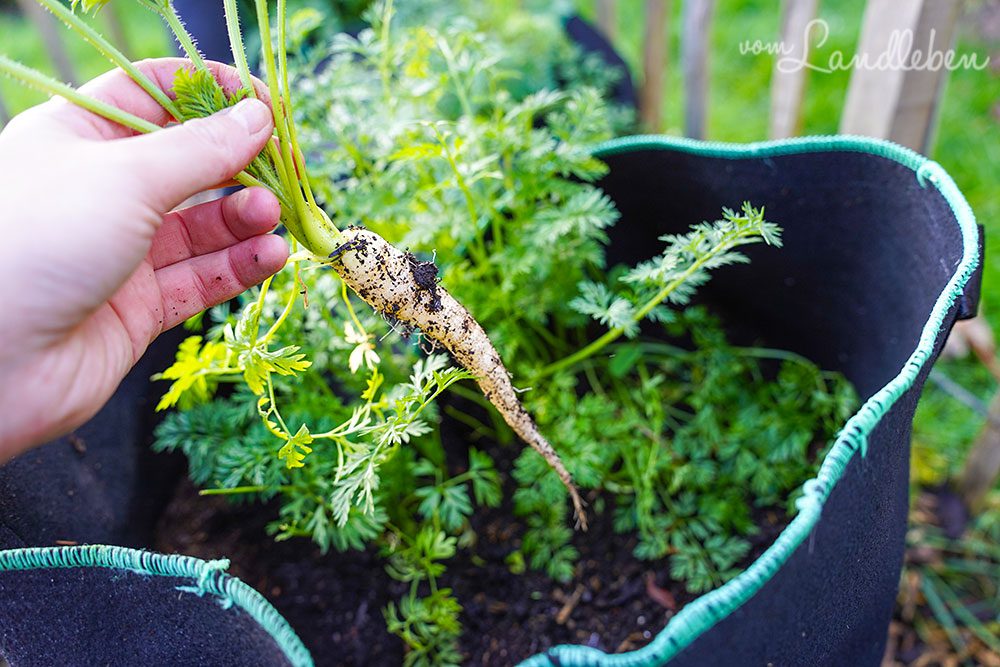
[840,0,960,152]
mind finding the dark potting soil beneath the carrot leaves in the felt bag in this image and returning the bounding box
[155,472,786,666]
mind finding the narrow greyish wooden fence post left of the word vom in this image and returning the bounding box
[681,0,715,139]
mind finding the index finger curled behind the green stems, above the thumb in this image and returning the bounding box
[39,58,270,139]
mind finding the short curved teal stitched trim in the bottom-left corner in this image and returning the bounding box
[0,545,313,667]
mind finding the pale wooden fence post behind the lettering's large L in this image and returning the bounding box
[771,0,819,139]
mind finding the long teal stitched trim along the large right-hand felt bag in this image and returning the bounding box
[521,135,980,667]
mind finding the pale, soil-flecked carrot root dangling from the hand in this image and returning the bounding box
[331,227,587,530]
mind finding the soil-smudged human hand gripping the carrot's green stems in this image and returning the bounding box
[0,58,288,462]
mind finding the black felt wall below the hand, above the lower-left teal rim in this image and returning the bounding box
[0,331,184,549]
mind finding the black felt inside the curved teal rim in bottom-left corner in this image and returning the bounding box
[0,568,289,667]
